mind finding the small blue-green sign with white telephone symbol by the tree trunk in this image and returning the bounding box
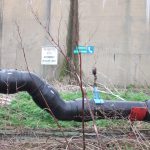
[74,46,94,54]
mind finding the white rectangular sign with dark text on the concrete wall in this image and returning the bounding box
[41,46,58,65]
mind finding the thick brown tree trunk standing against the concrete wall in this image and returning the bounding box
[60,0,79,79]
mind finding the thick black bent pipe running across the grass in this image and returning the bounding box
[0,70,150,121]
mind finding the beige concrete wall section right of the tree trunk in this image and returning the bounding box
[80,0,150,86]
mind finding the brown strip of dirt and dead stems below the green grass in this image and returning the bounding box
[0,128,150,150]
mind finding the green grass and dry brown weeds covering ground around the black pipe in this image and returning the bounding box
[0,90,150,150]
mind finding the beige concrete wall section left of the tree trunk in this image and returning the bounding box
[0,0,69,80]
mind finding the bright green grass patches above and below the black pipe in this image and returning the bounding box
[0,90,150,128]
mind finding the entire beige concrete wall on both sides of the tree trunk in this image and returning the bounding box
[0,0,150,86]
